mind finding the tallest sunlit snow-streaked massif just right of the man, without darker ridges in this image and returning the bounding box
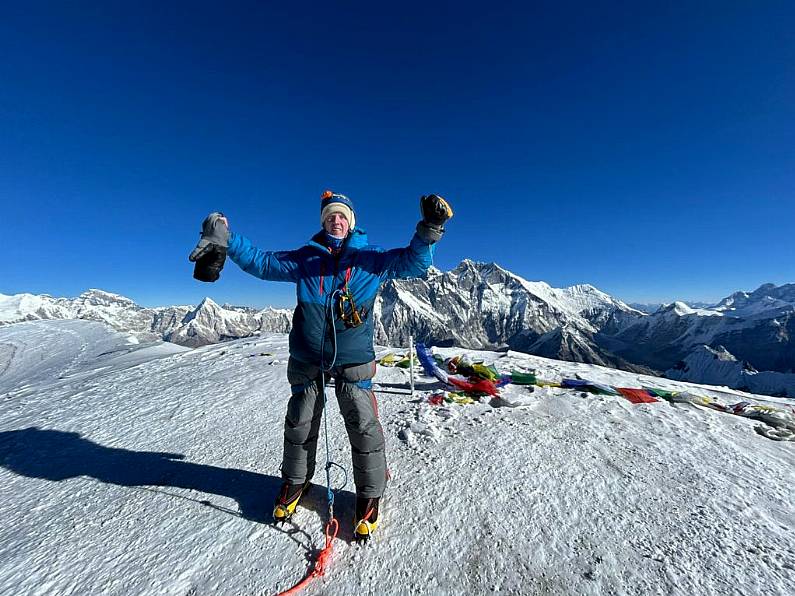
[376,260,644,369]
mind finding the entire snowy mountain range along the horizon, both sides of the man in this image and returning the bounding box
[0,260,795,396]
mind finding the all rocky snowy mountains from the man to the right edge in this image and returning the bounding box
[376,261,795,395]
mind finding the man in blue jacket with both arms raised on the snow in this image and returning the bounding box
[190,191,453,539]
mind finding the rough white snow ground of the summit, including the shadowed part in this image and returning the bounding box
[0,321,795,596]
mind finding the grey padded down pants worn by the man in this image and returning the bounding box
[282,358,387,498]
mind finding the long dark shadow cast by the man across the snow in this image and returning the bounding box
[0,427,352,523]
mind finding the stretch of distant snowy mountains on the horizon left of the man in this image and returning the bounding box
[0,290,292,347]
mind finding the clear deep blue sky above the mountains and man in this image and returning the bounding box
[0,1,795,306]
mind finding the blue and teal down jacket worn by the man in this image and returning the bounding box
[227,228,434,366]
